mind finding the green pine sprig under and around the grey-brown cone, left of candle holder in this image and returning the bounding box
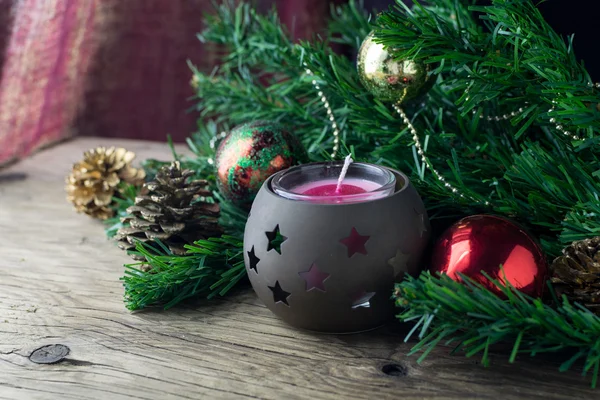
[105,122,248,311]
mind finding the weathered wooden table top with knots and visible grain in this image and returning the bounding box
[0,138,600,400]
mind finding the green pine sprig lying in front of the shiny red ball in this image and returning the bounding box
[394,272,600,387]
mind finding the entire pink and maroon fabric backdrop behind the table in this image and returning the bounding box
[0,0,336,165]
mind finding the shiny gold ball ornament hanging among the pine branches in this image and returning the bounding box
[358,32,435,103]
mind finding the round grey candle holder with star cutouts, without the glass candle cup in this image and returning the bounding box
[244,170,430,333]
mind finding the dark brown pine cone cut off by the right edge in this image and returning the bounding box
[551,237,600,315]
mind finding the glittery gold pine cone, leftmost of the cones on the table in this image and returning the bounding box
[66,147,146,220]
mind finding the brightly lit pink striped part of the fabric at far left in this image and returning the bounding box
[0,0,96,164]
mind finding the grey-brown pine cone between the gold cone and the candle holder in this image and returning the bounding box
[115,161,223,261]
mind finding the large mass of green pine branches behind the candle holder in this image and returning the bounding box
[194,0,600,255]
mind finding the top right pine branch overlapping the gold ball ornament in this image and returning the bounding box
[378,0,600,143]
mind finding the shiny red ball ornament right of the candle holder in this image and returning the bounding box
[431,215,548,297]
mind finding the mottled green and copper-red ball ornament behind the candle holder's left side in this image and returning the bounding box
[215,121,308,209]
